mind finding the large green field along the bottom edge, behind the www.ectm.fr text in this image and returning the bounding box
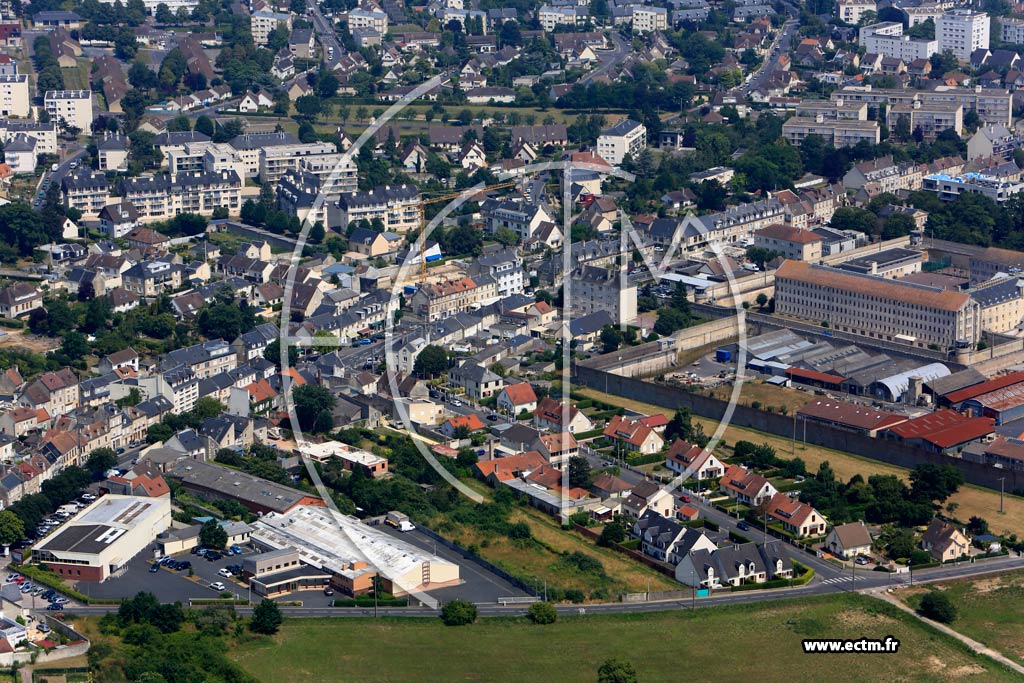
[229,595,1015,683]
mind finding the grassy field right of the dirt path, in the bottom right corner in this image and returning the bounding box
[898,571,1024,664]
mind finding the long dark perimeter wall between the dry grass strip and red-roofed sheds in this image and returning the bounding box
[572,366,1024,492]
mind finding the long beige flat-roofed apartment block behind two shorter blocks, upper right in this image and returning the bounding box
[830,85,1013,128]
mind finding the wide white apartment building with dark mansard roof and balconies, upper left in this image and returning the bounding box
[120,171,242,221]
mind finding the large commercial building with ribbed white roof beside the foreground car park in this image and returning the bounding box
[244,505,461,595]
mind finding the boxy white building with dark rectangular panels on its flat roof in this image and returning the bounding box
[32,494,171,582]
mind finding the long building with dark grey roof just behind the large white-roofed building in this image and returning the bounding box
[165,459,324,514]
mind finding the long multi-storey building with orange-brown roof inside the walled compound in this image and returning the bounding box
[775,261,981,349]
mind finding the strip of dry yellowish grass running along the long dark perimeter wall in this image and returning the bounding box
[578,387,1024,536]
